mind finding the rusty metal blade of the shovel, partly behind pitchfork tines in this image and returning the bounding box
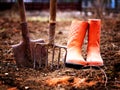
[12,39,48,68]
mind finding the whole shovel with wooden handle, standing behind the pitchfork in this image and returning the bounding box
[12,0,47,68]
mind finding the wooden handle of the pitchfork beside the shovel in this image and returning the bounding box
[49,0,57,45]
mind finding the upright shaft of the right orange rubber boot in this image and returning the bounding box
[87,19,101,52]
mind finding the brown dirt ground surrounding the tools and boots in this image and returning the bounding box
[0,10,120,90]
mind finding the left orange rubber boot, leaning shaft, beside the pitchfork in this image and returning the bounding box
[65,20,88,68]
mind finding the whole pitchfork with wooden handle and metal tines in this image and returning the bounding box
[34,0,67,69]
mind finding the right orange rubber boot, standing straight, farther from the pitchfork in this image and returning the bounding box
[87,19,103,66]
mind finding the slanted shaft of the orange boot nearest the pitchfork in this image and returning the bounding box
[67,20,88,48]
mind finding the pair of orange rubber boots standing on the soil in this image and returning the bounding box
[65,19,103,68]
